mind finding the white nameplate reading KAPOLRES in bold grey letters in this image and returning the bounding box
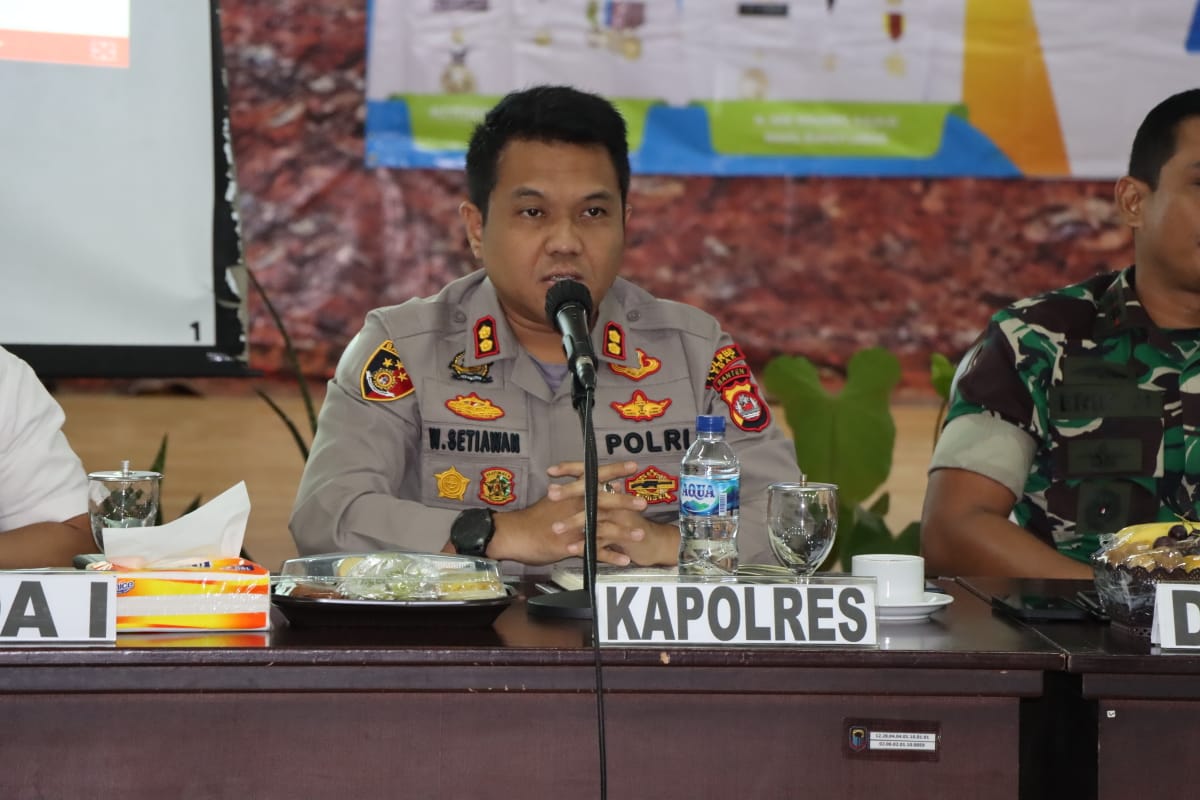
[596,581,876,646]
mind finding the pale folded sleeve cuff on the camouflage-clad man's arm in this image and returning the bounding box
[929,414,1034,499]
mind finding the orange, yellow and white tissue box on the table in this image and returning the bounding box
[94,558,271,633]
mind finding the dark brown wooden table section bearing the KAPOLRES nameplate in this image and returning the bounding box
[0,582,1070,800]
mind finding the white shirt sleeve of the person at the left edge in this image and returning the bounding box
[0,348,88,531]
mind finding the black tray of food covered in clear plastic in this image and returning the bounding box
[271,552,516,627]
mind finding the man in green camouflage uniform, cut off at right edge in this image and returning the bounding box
[922,90,1200,577]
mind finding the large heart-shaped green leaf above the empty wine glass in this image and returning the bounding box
[763,348,900,506]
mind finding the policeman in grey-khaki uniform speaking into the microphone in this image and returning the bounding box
[290,86,799,571]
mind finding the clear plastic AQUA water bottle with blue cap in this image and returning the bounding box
[679,414,742,578]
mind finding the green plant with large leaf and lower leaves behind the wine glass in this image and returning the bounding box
[763,348,921,569]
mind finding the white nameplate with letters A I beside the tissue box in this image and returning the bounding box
[0,571,116,644]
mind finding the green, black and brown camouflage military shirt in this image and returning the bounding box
[935,267,1200,560]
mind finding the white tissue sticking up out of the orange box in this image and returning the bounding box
[104,481,250,569]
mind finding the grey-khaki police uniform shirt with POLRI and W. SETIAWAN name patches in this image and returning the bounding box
[290,270,799,570]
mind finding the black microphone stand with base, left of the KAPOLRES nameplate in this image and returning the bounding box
[527,365,600,634]
